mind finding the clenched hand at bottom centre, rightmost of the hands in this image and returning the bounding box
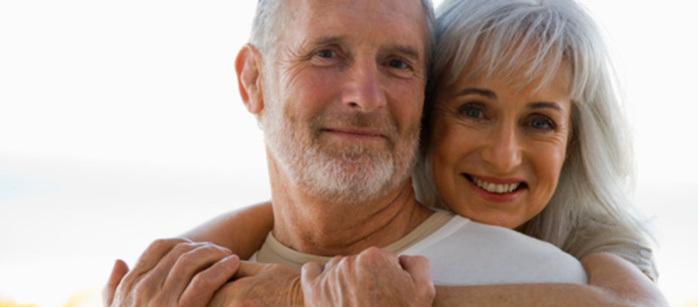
[301,247,436,306]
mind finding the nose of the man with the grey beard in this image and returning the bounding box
[343,61,387,112]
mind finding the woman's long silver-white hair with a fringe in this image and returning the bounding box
[415,0,655,278]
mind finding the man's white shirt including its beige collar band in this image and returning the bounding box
[250,211,587,286]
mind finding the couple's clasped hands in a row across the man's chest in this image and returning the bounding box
[103,238,435,306]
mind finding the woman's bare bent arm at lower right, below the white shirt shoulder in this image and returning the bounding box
[434,253,668,306]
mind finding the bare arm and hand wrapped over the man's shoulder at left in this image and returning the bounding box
[102,203,274,306]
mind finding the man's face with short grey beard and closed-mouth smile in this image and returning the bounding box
[262,0,427,203]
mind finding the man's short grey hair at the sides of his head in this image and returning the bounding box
[250,0,436,71]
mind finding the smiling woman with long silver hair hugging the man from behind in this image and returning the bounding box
[103,0,665,306]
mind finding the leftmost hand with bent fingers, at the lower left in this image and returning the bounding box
[103,239,240,306]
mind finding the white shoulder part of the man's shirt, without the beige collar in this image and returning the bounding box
[402,215,587,286]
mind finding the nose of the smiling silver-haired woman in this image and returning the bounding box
[481,125,521,174]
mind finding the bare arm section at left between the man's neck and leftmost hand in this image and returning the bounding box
[182,202,274,259]
